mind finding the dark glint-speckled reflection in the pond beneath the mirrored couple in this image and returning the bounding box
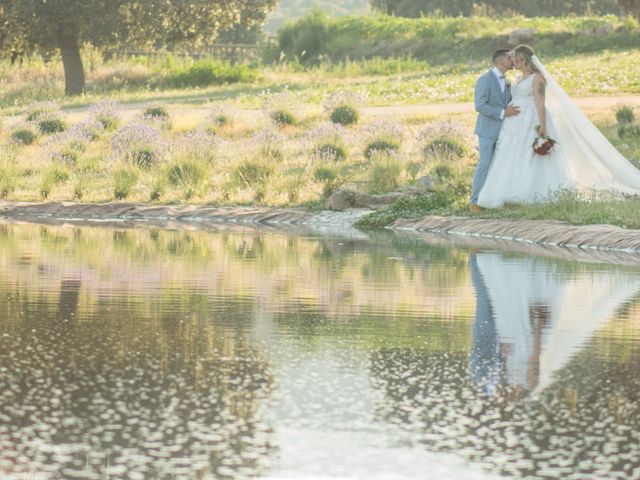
[371,349,640,478]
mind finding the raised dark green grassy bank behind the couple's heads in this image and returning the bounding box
[267,12,640,66]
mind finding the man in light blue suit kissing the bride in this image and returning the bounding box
[470,49,520,213]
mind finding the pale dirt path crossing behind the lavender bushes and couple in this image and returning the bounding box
[66,95,640,121]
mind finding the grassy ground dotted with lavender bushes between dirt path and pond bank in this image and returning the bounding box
[0,91,640,227]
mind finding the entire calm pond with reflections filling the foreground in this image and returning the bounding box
[0,224,640,480]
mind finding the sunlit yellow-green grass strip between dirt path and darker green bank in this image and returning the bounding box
[0,50,640,115]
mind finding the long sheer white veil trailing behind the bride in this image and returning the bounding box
[532,55,640,195]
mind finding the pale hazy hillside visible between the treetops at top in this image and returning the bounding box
[265,0,371,34]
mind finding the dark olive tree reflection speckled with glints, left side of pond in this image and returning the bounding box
[0,286,272,479]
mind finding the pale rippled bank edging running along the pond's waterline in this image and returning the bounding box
[0,202,640,256]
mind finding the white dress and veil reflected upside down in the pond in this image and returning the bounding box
[476,253,640,394]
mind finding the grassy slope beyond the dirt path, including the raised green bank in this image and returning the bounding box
[0,13,640,113]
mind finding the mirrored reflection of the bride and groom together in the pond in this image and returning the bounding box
[469,252,640,400]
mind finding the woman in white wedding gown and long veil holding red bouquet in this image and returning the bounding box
[478,45,640,208]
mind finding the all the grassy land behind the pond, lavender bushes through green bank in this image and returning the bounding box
[0,12,640,227]
